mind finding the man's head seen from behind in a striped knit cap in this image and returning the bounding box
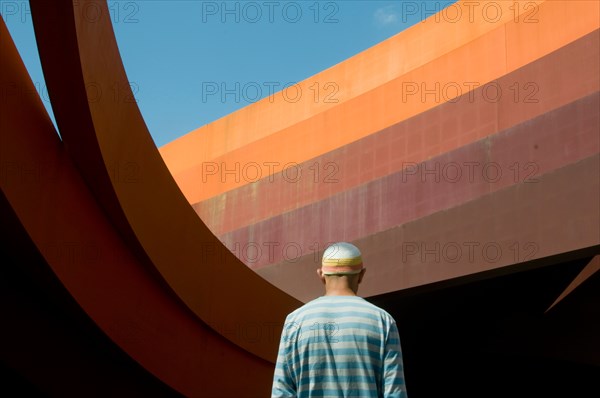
[317,242,366,295]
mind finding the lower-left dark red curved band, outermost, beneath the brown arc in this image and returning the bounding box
[0,17,277,397]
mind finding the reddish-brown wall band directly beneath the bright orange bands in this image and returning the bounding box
[194,31,600,236]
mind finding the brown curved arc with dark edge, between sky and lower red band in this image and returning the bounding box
[31,0,298,361]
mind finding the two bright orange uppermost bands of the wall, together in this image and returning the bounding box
[161,1,598,203]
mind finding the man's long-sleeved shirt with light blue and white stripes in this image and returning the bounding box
[271,296,406,398]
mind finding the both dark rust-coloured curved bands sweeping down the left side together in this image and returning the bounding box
[1,1,299,396]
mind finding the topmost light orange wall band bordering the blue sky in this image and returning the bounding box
[161,1,548,175]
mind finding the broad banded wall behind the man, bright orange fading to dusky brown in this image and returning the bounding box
[161,1,600,301]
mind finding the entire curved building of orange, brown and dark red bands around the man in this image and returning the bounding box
[0,0,600,398]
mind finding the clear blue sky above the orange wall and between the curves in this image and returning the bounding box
[0,0,453,146]
